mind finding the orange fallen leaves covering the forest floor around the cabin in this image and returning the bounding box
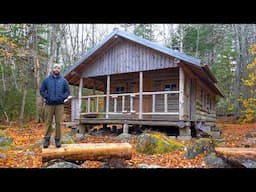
[0,121,256,168]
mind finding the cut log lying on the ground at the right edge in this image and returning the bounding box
[215,147,256,168]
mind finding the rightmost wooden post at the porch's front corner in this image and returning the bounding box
[179,67,185,120]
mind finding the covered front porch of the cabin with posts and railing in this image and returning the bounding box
[68,67,190,136]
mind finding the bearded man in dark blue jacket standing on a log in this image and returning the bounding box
[40,64,70,148]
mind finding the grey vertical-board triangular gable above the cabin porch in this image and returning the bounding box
[83,40,177,77]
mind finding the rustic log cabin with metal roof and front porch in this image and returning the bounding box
[64,28,223,136]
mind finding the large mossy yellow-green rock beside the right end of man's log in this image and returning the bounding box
[136,133,184,155]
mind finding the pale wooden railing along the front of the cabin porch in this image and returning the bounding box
[78,91,179,117]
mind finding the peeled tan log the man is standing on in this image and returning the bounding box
[42,143,132,162]
